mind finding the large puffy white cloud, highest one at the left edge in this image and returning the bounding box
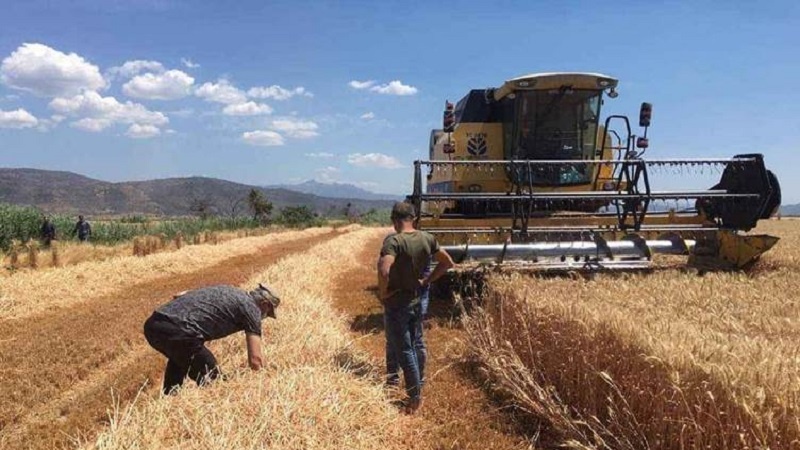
[0,43,106,97]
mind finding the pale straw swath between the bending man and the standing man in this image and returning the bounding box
[87,230,410,449]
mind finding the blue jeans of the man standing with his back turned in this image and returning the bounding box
[383,303,427,399]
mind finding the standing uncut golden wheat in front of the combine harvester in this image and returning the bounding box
[468,221,800,449]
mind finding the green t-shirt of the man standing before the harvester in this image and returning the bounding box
[381,231,439,306]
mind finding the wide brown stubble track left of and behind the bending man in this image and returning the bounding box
[0,231,340,449]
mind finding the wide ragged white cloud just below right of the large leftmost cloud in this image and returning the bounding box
[49,92,169,132]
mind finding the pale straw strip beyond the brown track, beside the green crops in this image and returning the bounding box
[0,228,331,319]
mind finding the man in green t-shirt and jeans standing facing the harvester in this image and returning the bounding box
[378,202,453,414]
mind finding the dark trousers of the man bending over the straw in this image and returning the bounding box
[144,312,220,394]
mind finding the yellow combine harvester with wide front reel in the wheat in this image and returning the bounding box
[408,73,780,270]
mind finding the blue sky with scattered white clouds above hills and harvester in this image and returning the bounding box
[0,0,800,203]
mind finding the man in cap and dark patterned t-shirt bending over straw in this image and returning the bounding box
[144,284,280,394]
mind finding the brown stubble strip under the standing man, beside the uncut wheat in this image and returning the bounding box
[333,232,532,449]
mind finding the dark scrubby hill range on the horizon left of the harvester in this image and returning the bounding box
[0,168,392,216]
